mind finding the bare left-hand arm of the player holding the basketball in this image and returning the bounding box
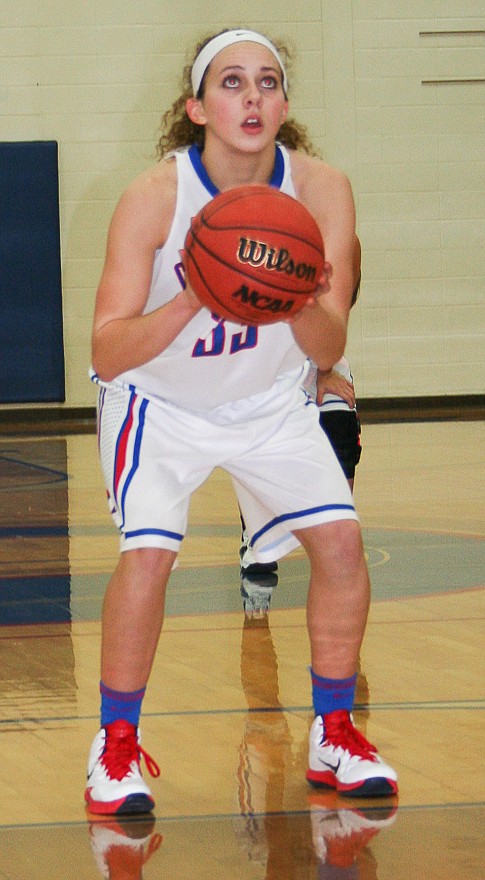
[92,166,201,381]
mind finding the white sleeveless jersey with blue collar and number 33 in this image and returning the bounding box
[91,146,306,423]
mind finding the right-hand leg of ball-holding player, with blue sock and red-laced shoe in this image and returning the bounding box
[295,520,397,797]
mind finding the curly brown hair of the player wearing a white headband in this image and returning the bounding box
[156,28,318,160]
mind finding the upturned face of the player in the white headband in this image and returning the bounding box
[187,42,288,152]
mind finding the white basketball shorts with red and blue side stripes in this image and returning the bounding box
[98,386,358,562]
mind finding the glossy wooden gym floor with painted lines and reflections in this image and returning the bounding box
[0,421,485,880]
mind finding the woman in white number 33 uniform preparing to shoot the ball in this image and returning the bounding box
[85,30,397,814]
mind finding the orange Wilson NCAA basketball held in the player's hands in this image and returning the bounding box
[185,185,324,325]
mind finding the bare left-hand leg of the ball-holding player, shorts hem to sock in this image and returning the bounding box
[101,547,176,691]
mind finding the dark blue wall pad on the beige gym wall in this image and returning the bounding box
[0,141,65,403]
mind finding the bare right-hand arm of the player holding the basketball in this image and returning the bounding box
[292,154,355,371]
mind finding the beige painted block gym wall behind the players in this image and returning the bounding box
[0,0,485,407]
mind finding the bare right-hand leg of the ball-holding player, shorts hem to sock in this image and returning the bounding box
[295,520,370,679]
